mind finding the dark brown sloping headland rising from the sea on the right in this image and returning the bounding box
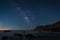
[34,21,60,31]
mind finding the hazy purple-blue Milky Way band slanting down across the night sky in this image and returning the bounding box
[10,0,37,26]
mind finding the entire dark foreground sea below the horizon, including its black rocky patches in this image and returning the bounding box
[0,30,60,40]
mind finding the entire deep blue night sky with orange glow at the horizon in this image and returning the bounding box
[0,0,60,30]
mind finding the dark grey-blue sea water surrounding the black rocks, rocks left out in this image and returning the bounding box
[0,30,60,40]
